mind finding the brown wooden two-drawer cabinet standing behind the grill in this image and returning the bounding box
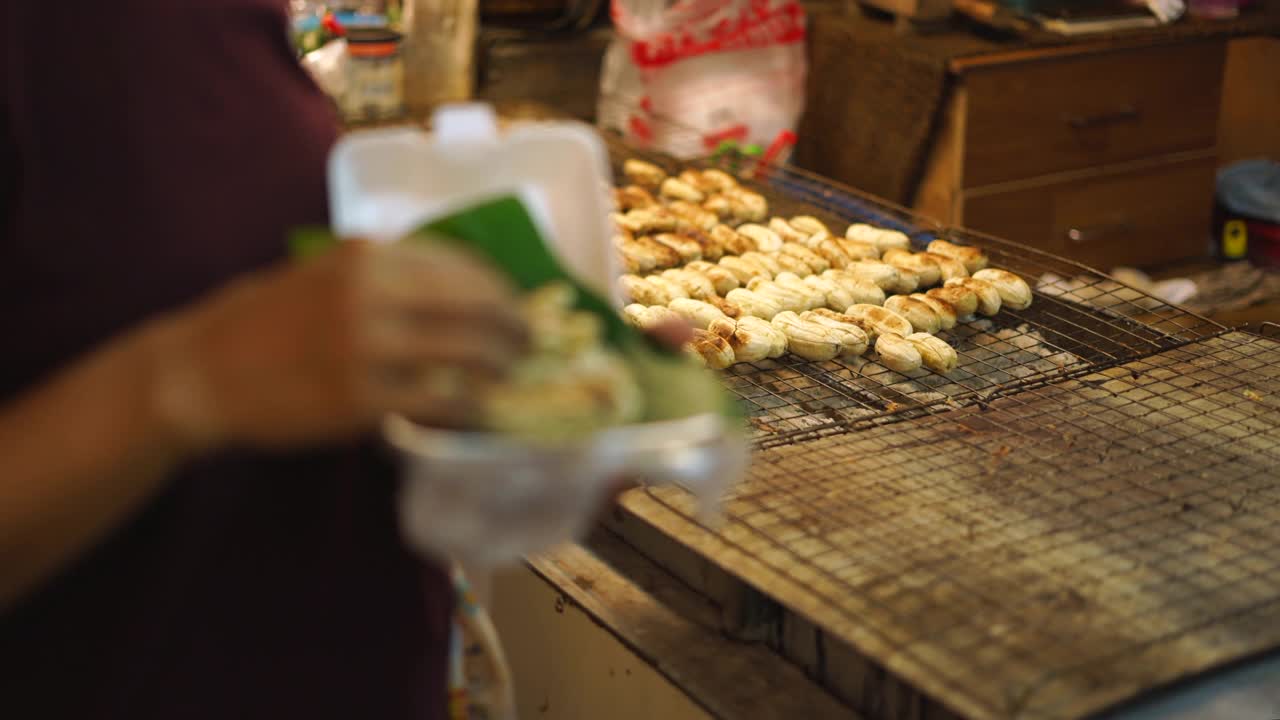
[915,41,1226,269]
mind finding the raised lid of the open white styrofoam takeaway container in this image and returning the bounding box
[329,104,620,302]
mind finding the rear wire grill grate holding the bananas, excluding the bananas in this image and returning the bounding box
[611,134,1225,443]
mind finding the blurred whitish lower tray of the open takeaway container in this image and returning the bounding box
[384,414,748,566]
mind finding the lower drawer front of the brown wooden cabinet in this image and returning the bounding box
[963,156,1217,270]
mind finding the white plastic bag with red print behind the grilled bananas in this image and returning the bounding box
[596,0,805,158]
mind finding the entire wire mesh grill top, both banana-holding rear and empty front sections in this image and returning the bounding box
[599,137,1280,719]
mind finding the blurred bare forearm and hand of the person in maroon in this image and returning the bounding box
[0,243,526,611]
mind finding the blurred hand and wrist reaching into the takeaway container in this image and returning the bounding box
[155,242,526,450]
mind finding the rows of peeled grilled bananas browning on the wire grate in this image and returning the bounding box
[604,160,1030,373]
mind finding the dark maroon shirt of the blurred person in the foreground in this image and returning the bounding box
[0,0,451,720]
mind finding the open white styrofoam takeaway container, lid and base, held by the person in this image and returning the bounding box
[329,105,748,568]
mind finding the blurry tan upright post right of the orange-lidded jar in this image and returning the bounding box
[399,0,479,117]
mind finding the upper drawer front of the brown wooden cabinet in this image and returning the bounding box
[963,42,1226,187]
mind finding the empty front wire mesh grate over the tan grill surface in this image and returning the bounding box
[649,333,1280,717]
